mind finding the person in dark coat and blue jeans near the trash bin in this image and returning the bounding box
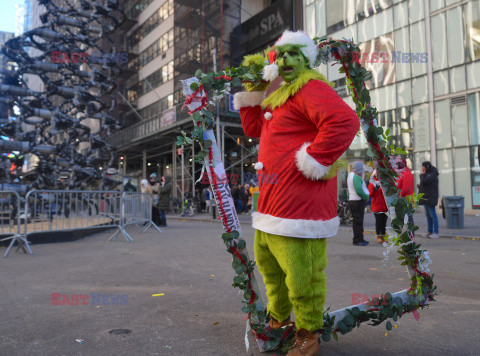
[418,161,438,239]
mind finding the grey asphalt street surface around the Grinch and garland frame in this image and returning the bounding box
[0,219,480,355]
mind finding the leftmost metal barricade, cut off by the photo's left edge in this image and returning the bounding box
[0,190,33,257]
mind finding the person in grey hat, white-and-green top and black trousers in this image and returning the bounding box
[347,161,370,246]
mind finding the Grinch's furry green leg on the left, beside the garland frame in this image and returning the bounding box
[254,230,292,321]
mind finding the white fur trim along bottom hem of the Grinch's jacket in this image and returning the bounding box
[252,211,340,239]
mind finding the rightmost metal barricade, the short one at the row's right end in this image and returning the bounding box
[117,192,163,238]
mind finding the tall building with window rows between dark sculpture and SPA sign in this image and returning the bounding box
[109,0,276,196]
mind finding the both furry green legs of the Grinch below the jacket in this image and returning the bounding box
[255,230,328,331]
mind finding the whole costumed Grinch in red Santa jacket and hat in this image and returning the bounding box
[234,31,360,355]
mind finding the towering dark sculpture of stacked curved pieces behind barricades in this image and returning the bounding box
[0,0,125,190]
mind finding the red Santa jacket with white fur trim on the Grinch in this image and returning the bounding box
[234,80,360,238]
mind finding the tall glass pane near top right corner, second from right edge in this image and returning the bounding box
[447,6,465,66]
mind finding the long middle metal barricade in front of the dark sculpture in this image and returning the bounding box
[20,190,133,242]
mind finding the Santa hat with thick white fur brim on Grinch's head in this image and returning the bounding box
[263,30,317,82]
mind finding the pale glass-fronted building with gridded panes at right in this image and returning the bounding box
[304,0,480,209]
